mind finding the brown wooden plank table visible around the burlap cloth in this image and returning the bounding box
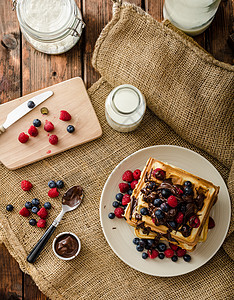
[0,0,234,300]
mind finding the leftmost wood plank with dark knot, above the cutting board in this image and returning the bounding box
[0,0,20,103]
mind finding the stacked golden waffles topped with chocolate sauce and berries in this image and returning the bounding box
[125,158,219,251]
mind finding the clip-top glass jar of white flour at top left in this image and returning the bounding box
[13,0,85,54]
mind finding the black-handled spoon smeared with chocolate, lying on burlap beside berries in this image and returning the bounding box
[27,185,83,263]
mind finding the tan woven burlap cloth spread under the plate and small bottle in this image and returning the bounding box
[0,1,233,299]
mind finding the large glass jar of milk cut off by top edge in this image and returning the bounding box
[163,0,221,36]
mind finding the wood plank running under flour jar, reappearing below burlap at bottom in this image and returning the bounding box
[22,0,83,300]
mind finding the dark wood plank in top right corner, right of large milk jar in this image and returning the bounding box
[206,0,234,64]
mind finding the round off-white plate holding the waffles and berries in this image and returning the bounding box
[100,145,231,277]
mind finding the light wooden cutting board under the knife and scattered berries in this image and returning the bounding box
[0,77,102,170]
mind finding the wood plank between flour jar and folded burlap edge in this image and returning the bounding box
[83,0,141,88]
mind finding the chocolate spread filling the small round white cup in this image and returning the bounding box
[55,233,79,258]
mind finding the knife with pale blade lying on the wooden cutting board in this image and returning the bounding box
[0,91,54,134]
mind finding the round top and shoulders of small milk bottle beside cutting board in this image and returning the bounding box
[105,84,146,126]
